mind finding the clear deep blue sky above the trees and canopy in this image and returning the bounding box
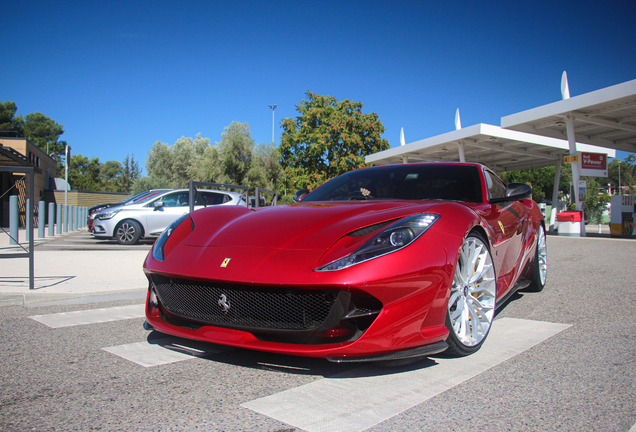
[0,0,636,172]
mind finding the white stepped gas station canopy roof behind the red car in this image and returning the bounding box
[366,74,636,172]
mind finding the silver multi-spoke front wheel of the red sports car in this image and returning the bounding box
[445,232,497,356]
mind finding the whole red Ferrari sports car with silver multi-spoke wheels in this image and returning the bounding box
[144,163,547,362]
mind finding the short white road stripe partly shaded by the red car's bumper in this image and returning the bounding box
[102,338,228,367]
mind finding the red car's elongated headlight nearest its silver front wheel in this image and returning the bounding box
[316,213,439,271]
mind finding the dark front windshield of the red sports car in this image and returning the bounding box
[302,164,482,202]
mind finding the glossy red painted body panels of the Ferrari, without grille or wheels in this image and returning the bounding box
[144,164,542,357]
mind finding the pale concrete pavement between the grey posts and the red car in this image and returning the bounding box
[0,230,148,306]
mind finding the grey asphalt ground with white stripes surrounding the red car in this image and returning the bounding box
[0,233,636,432]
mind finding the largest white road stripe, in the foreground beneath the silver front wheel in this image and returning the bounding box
[241,318,570,432]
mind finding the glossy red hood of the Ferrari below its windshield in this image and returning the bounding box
[184,201,438,251]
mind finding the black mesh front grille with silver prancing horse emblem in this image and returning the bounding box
[151,274,342,331]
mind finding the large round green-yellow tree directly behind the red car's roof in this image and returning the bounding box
[280,91,390,189]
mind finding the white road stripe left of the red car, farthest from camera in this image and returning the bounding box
[29,304,145,328]
